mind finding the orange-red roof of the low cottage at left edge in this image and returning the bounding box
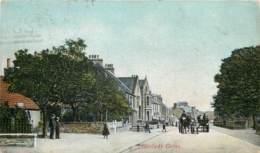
[0,76,39,110]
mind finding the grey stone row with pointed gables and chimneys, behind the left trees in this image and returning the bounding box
[89,55,172,125]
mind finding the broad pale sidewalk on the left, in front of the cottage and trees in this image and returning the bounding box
[1,127,172,153]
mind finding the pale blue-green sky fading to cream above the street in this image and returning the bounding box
[0,0,260,111]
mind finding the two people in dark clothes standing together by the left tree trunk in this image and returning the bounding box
[49,114,60,139]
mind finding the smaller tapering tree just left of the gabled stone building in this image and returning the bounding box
[94,66,131,121]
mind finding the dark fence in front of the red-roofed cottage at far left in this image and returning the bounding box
[0,119,32,133]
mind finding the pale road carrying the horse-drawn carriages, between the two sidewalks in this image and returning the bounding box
[126,128,260,153]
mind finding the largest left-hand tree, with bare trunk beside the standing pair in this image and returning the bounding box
[5,39,93,136]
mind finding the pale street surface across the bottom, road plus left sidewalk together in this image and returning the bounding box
[0,127,260,153]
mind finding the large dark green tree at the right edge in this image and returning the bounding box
[213,46,260,127]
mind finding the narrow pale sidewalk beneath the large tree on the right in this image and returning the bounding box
[211,126,260,146]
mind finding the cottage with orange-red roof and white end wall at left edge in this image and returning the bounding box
[0,76,41,128]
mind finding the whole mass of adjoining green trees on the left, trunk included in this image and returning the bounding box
[4,39,128,136]
